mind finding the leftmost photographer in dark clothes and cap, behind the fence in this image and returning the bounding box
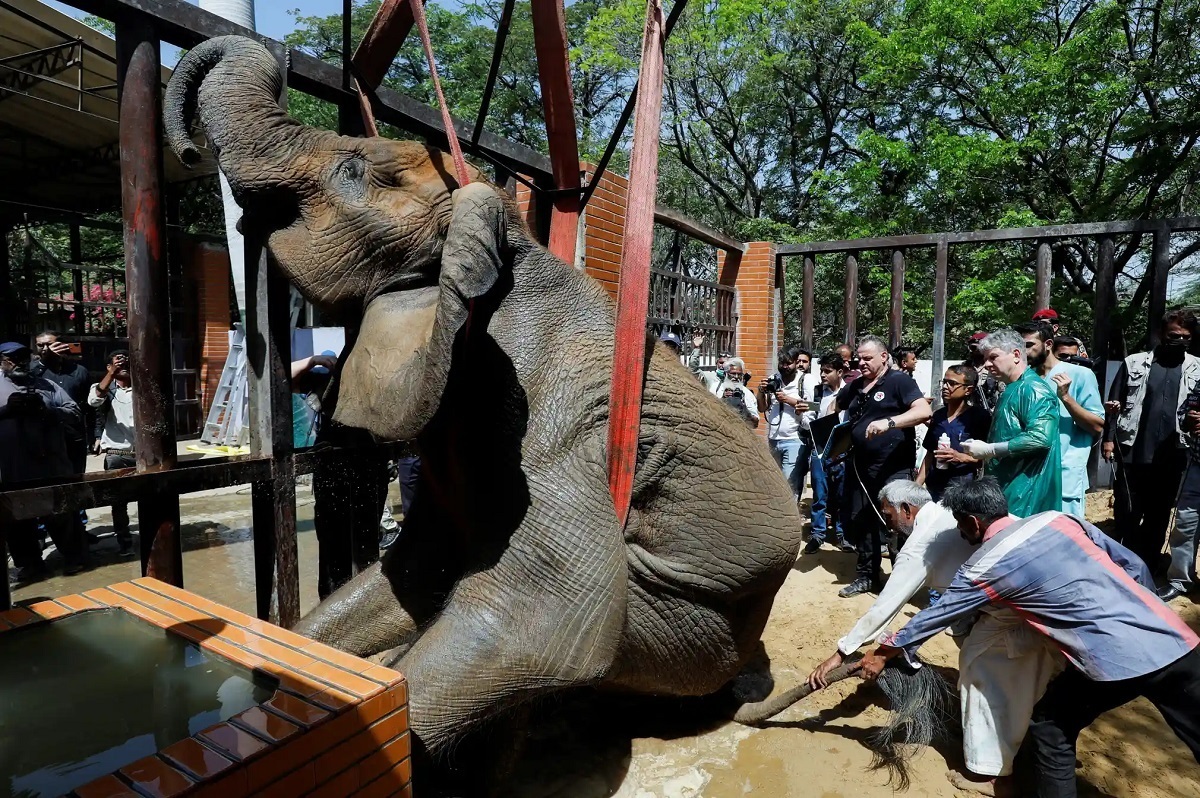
[0,342,83,584]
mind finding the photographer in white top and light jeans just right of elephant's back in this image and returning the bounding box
[758,344,812,502]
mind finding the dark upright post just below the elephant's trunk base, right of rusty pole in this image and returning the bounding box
[245,42,300,626]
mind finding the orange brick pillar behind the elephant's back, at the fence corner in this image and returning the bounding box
[716,241,784,436]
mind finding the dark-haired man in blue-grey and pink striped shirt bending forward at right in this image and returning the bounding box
[863,478,1200,798]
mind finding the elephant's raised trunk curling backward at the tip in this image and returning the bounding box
[163,36,311,198]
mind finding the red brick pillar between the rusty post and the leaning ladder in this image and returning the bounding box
[184,242,232,419]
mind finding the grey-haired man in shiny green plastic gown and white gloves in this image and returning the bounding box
[962,328,1062,518]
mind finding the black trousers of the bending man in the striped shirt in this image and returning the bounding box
[1026,648,1200,798]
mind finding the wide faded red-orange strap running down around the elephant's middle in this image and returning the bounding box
[608,0,667,528]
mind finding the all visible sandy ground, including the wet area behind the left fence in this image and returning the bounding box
[14,486,1200,798]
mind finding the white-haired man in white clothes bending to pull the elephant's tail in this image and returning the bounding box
[809,480,1063,796]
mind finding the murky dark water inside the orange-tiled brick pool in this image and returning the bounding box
[0,610,276,798]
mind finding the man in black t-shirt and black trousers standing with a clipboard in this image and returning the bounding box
[829,335,932,598]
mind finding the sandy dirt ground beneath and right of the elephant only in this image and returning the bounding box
[512,493,1200,798]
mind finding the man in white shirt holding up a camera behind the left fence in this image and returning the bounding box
[88,349,138,559]
